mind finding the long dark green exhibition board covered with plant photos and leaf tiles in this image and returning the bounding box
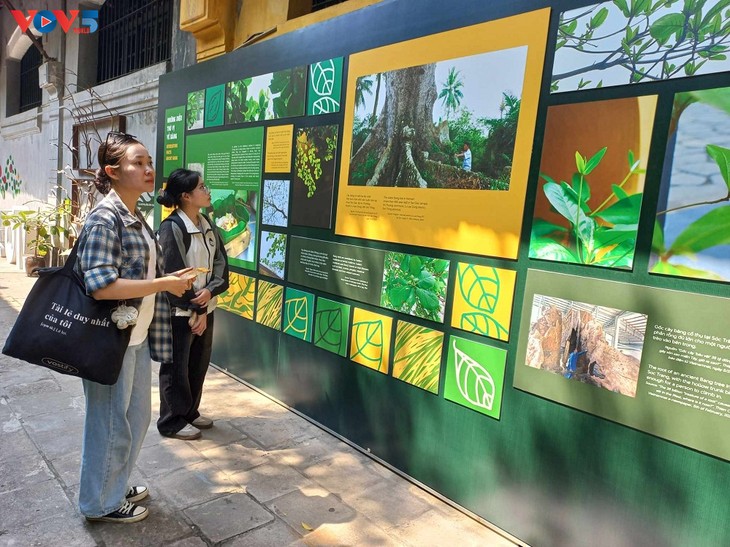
[157,0,730,546]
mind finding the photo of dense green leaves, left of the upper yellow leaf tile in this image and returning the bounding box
[380,253,449,322]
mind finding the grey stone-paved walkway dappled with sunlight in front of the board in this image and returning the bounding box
[0,258,515,547]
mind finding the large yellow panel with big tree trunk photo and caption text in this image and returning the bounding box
[335,9,550,258]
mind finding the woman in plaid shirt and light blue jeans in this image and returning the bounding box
[75,132,193,522]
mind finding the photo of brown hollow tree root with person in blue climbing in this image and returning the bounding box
[525,294,647,397]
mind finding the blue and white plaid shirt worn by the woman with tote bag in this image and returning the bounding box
[74,190,172,363]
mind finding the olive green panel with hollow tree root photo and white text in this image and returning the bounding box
[515,270,730,460]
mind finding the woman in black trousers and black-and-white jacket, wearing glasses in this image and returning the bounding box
[157,169,228,440]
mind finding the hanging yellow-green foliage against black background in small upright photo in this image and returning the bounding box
[294,125,337,198]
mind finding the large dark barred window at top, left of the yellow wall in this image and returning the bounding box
[96,0,172,83]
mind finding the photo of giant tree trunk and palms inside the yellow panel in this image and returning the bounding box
[349,46,527,190]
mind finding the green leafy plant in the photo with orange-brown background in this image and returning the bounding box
[530,148,643,268]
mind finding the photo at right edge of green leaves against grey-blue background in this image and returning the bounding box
[649,87,730,283]
